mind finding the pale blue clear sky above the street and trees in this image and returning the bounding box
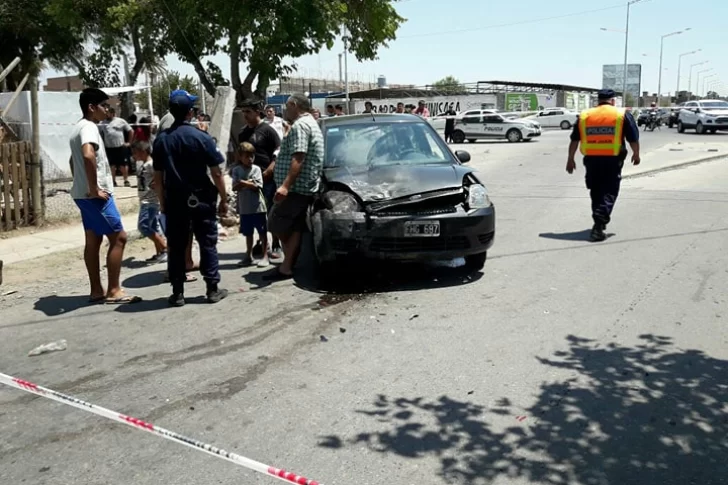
[45,0,728,94]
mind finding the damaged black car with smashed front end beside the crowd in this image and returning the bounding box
[309,114,495,270]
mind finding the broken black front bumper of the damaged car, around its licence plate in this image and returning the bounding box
[311,206,495,261]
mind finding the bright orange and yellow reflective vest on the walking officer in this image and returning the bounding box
[579,104,624,157]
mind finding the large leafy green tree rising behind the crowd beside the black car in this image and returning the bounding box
[158,0,405,101]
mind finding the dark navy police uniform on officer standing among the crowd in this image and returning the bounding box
[152,120,225,295]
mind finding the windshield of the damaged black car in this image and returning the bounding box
[324,121,453,171]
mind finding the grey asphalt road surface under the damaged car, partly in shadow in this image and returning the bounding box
[0,125,728,485]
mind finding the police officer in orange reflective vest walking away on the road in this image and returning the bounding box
[566,89,640,241]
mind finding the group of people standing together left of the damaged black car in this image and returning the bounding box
[70,88,324,306]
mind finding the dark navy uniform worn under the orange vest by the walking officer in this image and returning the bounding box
[571,93,639,235]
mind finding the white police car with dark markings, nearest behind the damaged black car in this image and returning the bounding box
[452,110,541,143]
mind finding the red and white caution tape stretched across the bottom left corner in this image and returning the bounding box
[0,373,321,485]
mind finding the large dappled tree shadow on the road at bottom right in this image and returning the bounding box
[319,335,728,485]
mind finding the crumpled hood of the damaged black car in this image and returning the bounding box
[324,164,473,202]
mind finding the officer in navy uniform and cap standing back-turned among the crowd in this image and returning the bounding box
[152,89,228,306]
